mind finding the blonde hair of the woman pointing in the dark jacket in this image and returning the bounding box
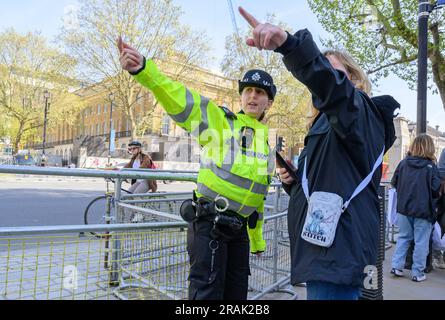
[307,50,372,130]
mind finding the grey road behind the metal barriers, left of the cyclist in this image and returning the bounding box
[0,175,194,227]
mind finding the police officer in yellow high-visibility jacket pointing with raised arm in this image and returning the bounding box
[118,39,276,300]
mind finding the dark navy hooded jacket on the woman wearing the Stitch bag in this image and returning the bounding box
[276,30,400,286]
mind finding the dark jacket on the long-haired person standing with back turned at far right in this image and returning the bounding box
[391,156,440,222]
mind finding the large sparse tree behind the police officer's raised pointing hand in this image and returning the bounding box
[60,0,208,138]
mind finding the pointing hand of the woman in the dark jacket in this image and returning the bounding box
[239,7,287,50]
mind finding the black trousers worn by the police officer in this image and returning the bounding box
[187,219,250,300]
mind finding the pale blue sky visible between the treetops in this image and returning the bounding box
[0,0,445,131]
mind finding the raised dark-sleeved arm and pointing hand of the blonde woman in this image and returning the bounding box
[240,8,373,141]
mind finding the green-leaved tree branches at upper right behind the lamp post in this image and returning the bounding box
[308,0,445,108]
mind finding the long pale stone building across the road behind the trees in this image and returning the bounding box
[27,60,239,167]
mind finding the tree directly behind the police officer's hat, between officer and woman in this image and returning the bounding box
[221,16,311,147]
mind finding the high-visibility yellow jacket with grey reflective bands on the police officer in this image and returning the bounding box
[131,60,275,253]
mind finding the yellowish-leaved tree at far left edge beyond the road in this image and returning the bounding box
[0,29,82,152]
